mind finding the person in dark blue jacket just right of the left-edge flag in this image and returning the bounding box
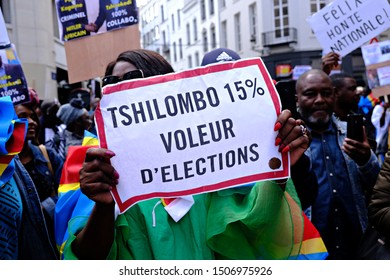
[15,94,64,249]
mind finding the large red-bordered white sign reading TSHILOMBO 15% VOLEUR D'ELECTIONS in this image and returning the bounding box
[95,58,289,212]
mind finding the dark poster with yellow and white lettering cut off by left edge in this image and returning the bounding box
[0,45,30,105]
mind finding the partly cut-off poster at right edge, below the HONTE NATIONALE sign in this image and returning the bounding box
[361,40,390,97]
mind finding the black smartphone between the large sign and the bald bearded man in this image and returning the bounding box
[275,80,300,119]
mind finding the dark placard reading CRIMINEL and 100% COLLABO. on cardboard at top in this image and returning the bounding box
[56,0,138,41]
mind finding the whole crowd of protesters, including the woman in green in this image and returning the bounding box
[0,48,390,260]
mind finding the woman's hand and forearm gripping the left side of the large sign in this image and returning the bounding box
[72,148,119,259]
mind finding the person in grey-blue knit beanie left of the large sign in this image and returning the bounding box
[57,98,92,158]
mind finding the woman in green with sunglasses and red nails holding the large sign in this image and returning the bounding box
[59,50,326,260]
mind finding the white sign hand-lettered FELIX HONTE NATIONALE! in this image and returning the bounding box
[307,0,390,56]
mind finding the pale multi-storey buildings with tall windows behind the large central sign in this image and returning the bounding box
[140,0,389,85]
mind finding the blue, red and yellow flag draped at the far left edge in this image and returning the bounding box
[0,96,28,186]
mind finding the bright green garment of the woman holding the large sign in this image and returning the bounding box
[64,181,303,260]
